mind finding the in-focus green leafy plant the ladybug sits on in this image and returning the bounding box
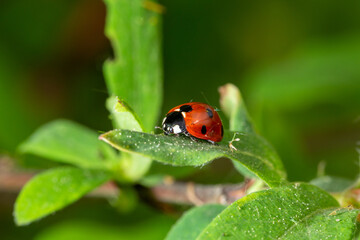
[14,0,360,239]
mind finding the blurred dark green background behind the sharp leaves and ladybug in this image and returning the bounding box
[0,0,360,239]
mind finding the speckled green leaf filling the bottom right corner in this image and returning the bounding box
[279,208,360,240]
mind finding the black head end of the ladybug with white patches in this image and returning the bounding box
[162,112,186,135]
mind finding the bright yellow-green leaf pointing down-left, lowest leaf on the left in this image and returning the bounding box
[14,167,111,226]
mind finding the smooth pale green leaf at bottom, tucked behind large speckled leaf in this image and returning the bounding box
[166,204,226,240]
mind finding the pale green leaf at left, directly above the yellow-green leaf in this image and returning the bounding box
[19,120,116,169]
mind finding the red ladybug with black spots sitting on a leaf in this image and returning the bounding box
[162,102,224,143]
